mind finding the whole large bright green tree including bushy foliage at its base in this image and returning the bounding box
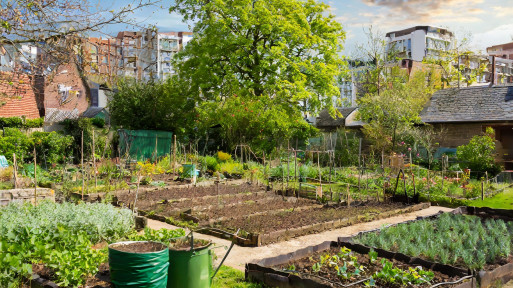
[170,0,345,150]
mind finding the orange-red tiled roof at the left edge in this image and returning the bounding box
[0,72,40,119]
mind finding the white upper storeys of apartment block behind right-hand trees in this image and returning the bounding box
[386,26,454,62]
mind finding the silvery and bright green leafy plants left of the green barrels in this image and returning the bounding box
[0,201,133,287]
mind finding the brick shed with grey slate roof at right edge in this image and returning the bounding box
[420,86,513,170]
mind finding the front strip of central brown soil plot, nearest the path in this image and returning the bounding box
[200,203,430,246]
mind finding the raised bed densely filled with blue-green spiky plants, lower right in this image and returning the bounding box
[339,207,513,287]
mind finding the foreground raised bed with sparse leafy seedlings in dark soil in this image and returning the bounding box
[246,241,472,288]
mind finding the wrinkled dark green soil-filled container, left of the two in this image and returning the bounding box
[109,241,169,288]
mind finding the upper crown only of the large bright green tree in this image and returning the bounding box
[170,0,345,112]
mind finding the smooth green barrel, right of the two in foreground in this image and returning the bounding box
[167,244,213,288]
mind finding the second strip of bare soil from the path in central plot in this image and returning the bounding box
[193,196,317,225]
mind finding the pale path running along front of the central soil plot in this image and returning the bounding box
[148,206,452,270]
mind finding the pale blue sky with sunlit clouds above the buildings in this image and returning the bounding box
[102,0,513,56]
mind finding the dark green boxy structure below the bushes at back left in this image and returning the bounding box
[118,129,173,161]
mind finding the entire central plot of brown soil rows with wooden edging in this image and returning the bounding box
[118,184,429,246]
